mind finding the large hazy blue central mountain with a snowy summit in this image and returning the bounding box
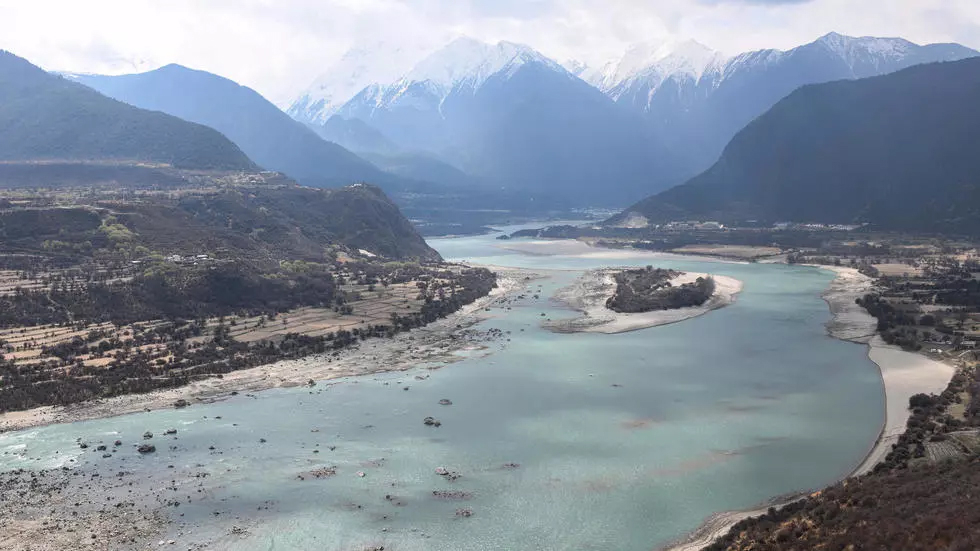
[338,40,669,204]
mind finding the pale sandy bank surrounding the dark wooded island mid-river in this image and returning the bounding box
[544,268,743,334]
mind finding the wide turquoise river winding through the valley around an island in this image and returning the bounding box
[0,226,884,551]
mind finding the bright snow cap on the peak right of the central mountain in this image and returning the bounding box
[584,40,724,92]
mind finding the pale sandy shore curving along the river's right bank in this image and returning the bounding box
[659,264,956,551]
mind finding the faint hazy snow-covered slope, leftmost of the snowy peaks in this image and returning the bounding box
[287,42,426,125]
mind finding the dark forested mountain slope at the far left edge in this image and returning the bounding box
[0,51,256,170]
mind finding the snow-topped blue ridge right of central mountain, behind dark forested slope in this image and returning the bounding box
[580,33,978,177]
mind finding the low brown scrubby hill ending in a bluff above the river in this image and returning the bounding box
[0,176,439,266]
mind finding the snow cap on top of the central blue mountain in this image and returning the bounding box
[402,37,565,91]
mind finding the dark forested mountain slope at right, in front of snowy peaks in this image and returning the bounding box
[614,58,980,232]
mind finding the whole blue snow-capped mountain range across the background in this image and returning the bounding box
[290,33,978,205]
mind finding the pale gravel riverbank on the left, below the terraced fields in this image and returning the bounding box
[0,268,539,433]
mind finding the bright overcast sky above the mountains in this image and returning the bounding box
[0,0,980,104]
